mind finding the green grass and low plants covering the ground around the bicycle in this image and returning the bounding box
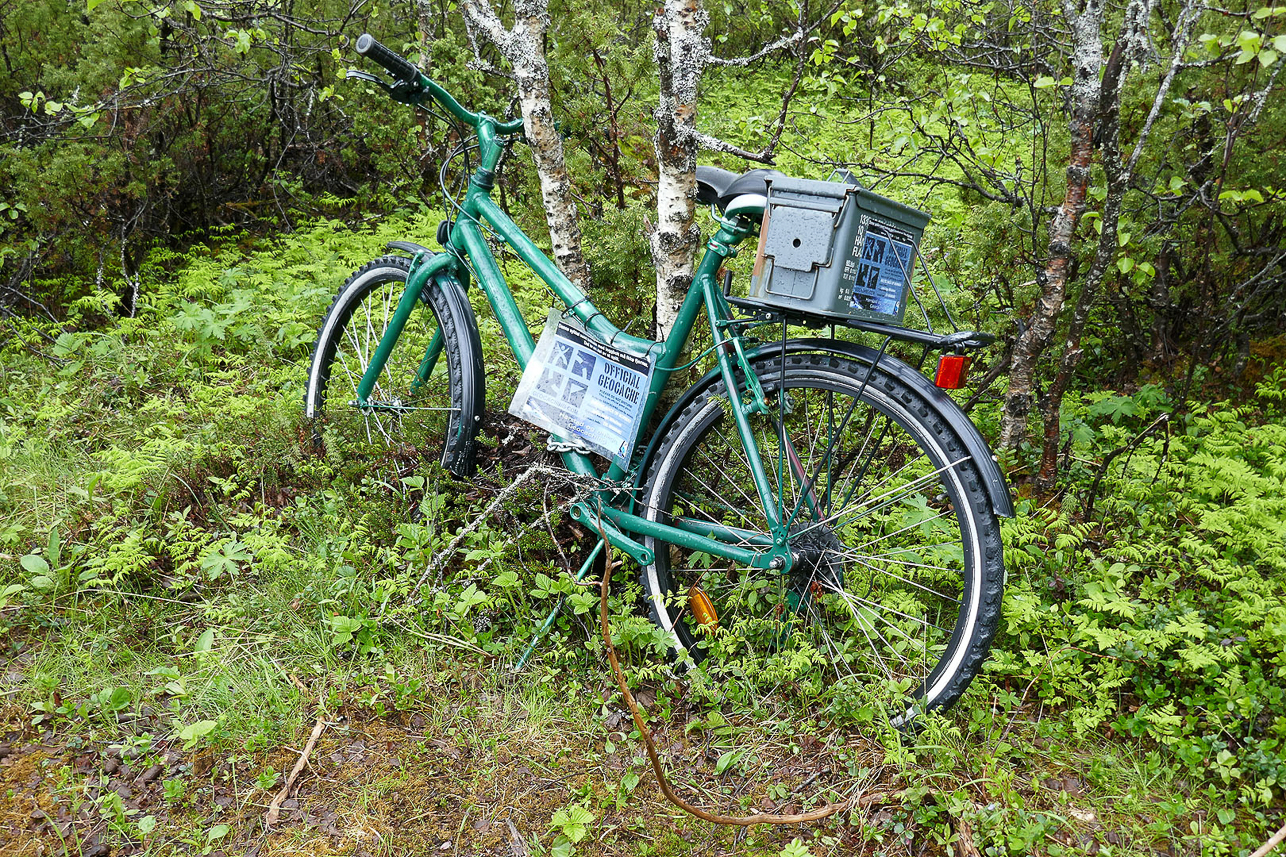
[0,203,1286,854]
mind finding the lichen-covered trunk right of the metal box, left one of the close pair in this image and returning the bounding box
[1001,0,1103,449]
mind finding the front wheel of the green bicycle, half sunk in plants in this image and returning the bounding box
[305,256,484,476]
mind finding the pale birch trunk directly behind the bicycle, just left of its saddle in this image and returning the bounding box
[649,0,710,337]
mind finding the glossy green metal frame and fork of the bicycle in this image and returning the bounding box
[354,98,791,571]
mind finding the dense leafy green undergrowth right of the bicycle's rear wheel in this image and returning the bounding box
[989,368,1286,824]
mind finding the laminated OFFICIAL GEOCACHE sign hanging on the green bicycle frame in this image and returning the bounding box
[509,310,653,467]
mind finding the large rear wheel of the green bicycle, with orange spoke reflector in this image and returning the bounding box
[640,354,1004,726]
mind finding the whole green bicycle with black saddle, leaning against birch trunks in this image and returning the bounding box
[306,35,1013,723]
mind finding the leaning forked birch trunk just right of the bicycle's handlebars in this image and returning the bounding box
[463,0,589,288]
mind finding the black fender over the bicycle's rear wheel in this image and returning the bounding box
[638,338,1013,517]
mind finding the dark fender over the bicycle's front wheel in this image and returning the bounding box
[388,241,486,479]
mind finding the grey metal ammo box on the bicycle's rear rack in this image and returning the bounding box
[747,178,930,324]
